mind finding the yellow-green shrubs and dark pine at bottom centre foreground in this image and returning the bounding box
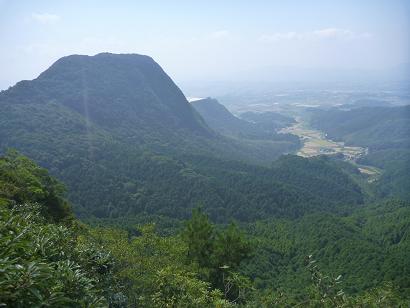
[91,212,251,307]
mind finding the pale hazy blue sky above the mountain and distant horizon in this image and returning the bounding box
[0,0,410,89]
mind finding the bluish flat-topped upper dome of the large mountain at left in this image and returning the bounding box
[0,53,209,135]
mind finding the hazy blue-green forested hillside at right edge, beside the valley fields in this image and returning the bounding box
[311,106,410,200]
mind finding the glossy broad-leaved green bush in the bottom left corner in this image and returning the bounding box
[0,204,122,307]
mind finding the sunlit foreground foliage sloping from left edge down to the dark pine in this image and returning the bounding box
[0,152,240,307]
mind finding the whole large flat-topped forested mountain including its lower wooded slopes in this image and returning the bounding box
[0,54,363,221]
